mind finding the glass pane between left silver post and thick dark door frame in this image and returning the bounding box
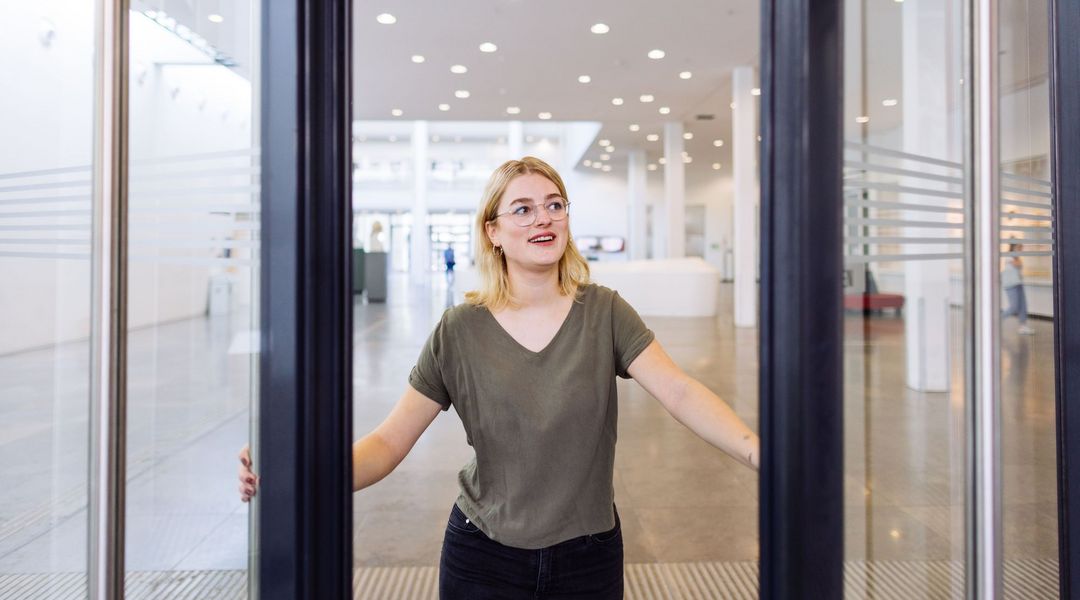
[125,0,259,598]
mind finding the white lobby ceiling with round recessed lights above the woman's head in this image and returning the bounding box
[353,0,759,166]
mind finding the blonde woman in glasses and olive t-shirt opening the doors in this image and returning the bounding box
[240,156,758,600]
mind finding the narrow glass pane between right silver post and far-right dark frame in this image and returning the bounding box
[1000,0,1058,598]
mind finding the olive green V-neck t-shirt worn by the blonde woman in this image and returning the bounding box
[409,285,653,549]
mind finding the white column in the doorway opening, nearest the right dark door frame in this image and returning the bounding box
[731,67,758,327]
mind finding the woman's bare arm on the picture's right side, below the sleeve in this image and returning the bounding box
[626,340,760,469]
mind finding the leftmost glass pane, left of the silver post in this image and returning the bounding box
[0,2,94,598]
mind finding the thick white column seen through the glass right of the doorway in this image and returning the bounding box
[902,0,959,392]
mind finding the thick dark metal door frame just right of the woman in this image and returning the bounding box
[759,0,843,599]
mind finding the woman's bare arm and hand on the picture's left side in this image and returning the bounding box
[240,385,442,502]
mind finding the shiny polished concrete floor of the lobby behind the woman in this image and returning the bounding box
[0,277,1057,595]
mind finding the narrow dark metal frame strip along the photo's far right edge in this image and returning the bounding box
[1049,0,1080,598]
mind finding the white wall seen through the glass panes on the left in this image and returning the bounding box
[0,8,251,354]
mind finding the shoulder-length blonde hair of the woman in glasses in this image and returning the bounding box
[465,156,589,311]
